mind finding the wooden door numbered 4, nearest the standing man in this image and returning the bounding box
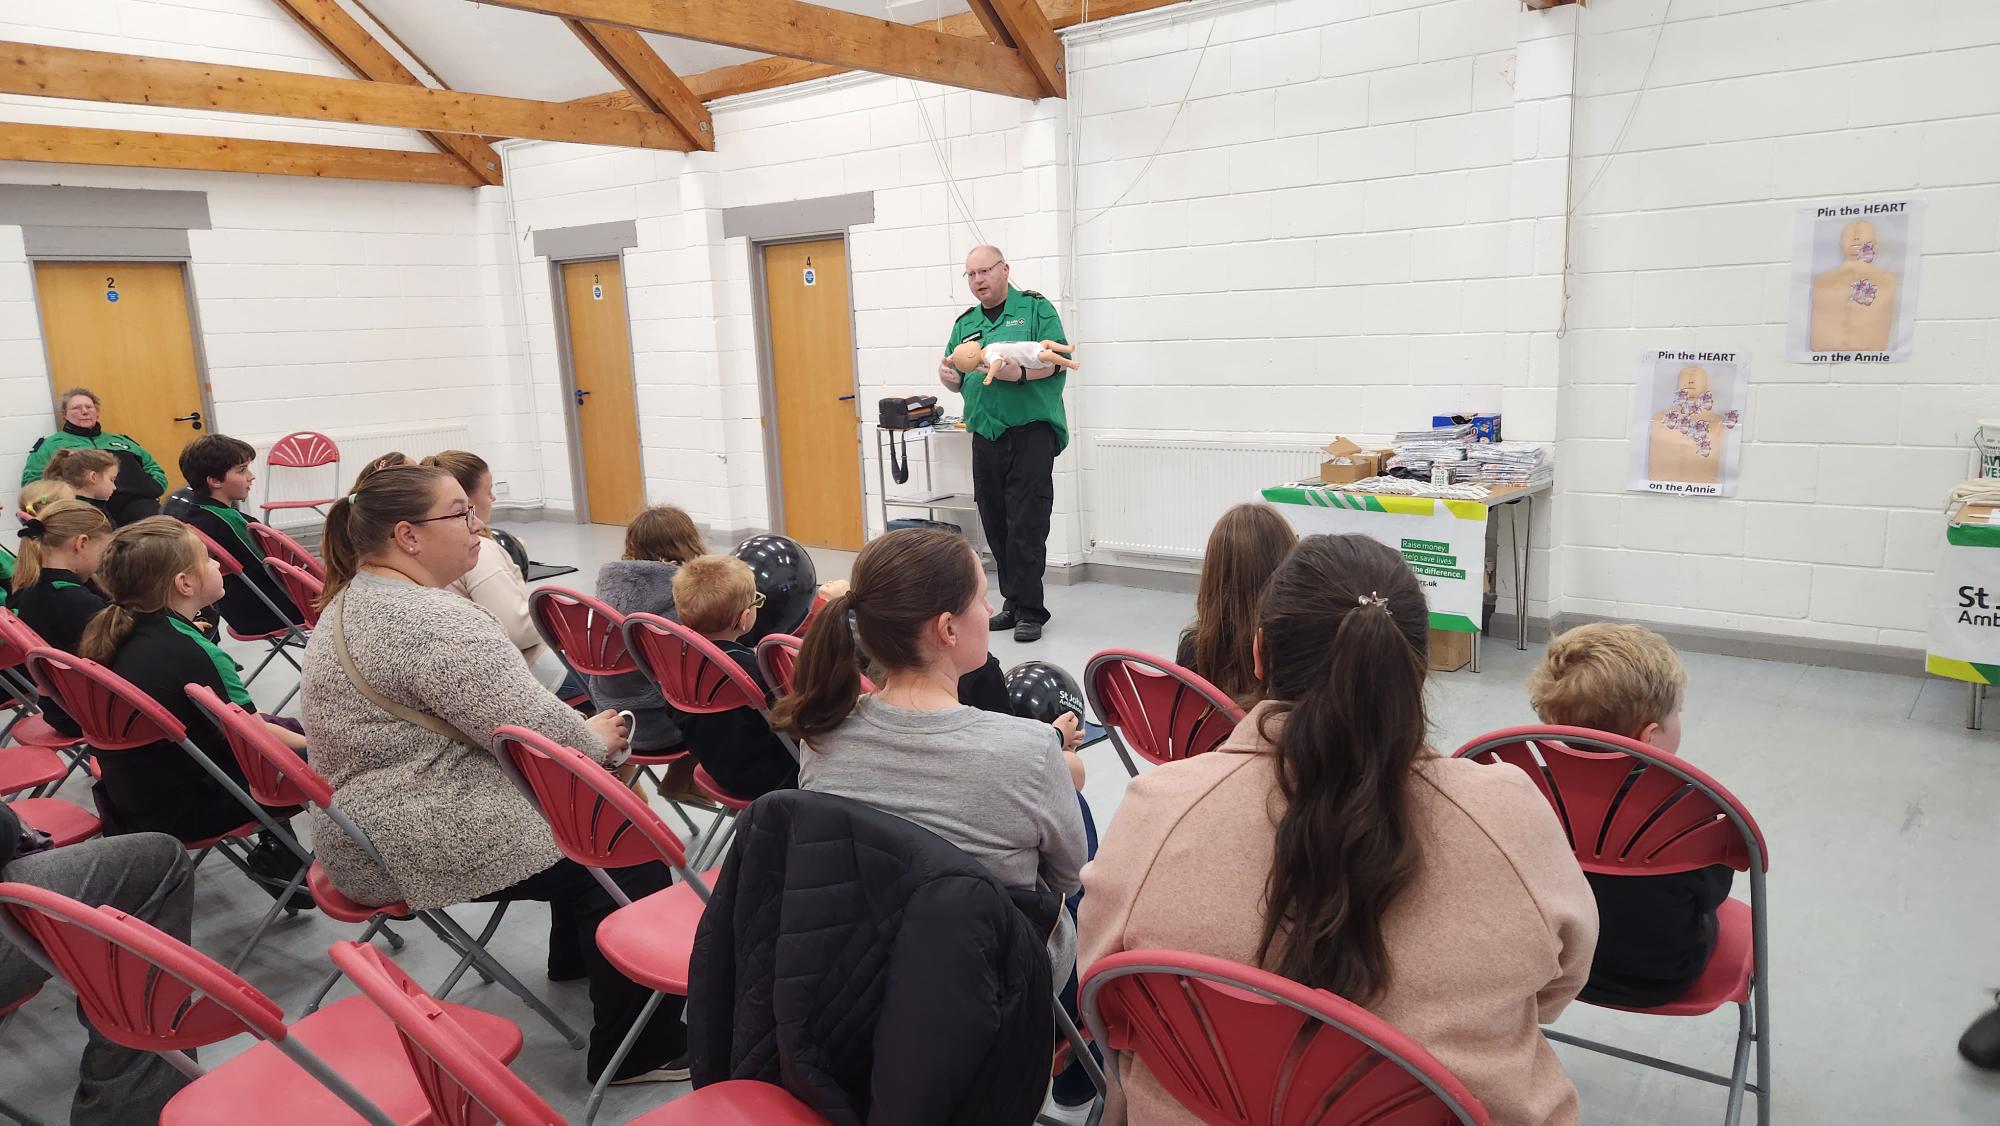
[764,238,862,552]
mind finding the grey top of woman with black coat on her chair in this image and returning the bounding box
[798,696,1084,894]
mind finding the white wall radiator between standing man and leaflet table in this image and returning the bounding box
[1086,438,1326,560]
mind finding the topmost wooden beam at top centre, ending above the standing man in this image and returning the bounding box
[488,0,1042,98]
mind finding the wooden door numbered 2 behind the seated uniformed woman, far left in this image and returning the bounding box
[34,262,214,474]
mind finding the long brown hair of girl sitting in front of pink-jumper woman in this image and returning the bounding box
[1194,504,1298,704]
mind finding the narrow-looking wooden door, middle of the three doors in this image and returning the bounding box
[562,258,646,524]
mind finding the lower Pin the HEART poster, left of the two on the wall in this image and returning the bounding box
[1626,348,1750,496]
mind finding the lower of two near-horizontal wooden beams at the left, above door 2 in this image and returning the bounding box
[0,122,482,188]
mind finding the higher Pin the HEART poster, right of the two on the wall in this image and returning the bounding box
[1784,196,1924,364]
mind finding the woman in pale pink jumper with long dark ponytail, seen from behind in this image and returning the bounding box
[1080,536,1598,1126]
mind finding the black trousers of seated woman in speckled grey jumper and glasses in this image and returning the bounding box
[478,860,688,1082]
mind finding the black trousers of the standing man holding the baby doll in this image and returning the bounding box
[972,422,1056,622]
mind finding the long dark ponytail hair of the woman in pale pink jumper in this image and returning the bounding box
[1258,536,1430,1004]
